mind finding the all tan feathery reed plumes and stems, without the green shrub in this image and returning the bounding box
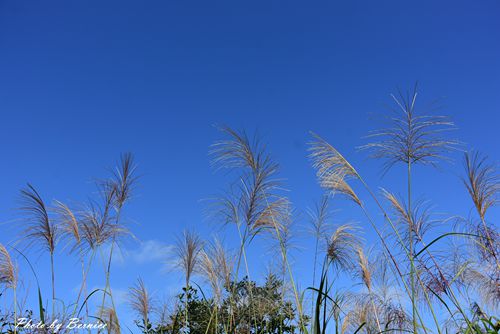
[0,89,500,334]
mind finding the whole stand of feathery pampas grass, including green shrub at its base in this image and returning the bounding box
[0,89,500,334]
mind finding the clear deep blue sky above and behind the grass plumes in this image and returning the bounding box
[0,0,500,328]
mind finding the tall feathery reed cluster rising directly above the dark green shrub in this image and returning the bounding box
[210,127,303,332]
